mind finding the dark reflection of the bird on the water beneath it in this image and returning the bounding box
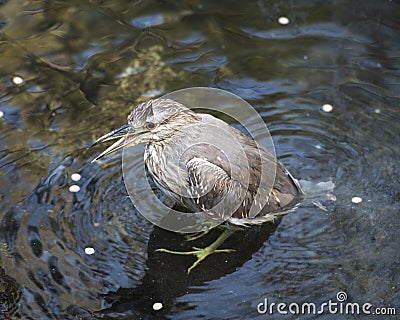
[100,219,280,319]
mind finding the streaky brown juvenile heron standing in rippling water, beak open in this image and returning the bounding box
[93,98,303,272]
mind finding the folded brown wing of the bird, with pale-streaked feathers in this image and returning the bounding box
[181,115,299,218]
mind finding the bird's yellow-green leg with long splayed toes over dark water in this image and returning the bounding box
[156,229,235,274]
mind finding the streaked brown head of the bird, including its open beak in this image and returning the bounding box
[92,98,199,162]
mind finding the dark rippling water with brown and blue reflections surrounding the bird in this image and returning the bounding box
[0,0,400,319]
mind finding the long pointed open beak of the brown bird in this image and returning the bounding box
[90,124,140,162]
